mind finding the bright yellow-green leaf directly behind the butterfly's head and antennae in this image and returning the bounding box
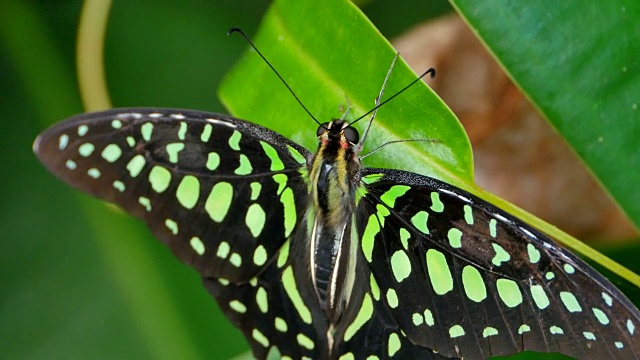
[220,0,473,187]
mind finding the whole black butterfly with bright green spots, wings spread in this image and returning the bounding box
[34,61,640,359]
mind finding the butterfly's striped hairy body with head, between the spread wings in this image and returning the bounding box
[309,120,361,324]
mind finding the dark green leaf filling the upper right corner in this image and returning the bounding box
[453,0,640,231]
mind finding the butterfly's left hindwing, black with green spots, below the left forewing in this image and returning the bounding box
[204,241,328,359]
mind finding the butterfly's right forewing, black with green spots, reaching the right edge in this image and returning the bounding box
[358,169,640,359]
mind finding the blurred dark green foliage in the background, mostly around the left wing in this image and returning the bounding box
[0,0,638,359]
